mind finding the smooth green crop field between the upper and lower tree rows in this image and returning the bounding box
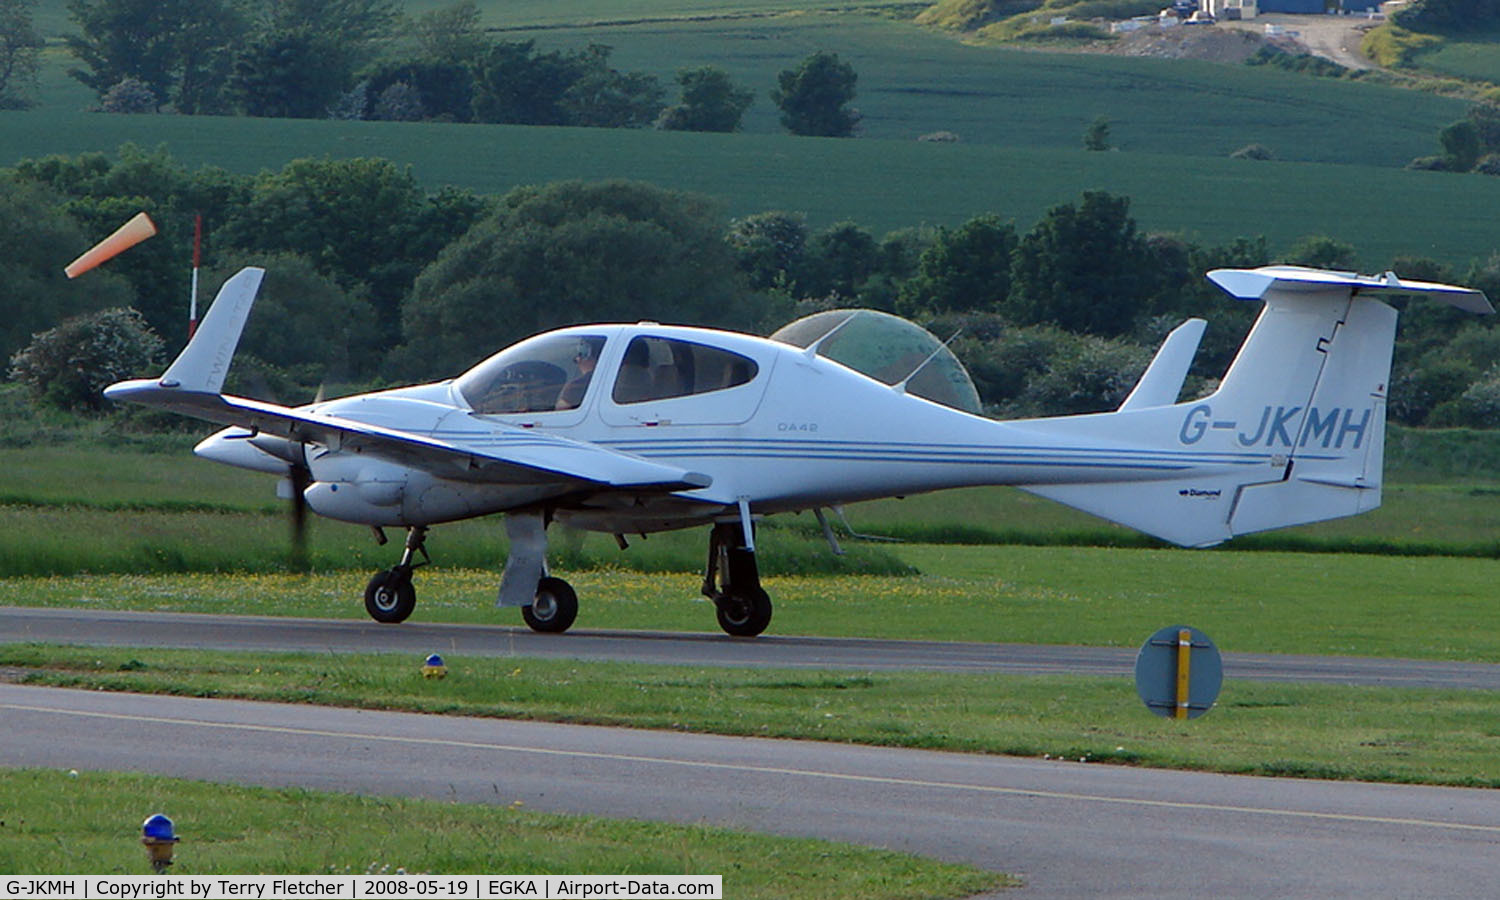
[0,110,1500,264]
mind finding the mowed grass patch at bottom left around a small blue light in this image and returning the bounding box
[0,770,1011,900]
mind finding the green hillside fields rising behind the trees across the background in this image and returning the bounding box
[0,0,1500,269]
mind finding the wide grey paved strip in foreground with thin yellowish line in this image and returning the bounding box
[0,684,1500,899]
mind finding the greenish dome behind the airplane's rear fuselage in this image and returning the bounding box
[771,309,983,416]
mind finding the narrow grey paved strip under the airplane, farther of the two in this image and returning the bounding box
[0,606,1500,690]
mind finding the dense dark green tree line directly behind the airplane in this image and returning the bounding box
[0,146,1500,428]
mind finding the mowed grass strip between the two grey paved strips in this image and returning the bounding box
[11,645,1500,786]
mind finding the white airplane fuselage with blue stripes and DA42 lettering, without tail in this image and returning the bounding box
[198,324,1274,533]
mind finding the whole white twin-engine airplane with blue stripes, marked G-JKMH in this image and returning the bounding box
[105,266,1494,636]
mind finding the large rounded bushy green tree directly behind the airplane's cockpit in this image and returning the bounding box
[395,182,759,377]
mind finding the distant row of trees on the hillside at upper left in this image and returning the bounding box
[0,0,860,137]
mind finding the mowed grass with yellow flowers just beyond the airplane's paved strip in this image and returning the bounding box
[0,546,1500,663]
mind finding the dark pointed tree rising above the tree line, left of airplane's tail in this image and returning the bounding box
[1002,191,1160,336]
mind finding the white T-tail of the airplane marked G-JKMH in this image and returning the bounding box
[1028,266,1494,546]
